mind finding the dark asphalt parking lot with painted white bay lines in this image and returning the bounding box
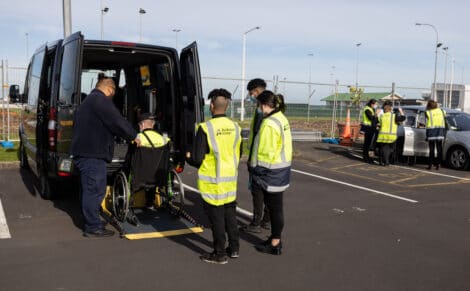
[0,144,470,290]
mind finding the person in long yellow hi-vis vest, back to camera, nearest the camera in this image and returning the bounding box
[186,89,242,264]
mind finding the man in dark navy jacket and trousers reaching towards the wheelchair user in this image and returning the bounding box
[71,78,140,237]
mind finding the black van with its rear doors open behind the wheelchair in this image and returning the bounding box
[19,32,204,199]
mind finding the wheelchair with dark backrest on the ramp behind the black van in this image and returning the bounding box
[109,144,185,222]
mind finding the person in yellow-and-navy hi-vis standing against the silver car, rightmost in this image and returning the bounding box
[426,100,446,170]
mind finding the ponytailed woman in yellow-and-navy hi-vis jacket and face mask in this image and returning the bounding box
[250,91,292,255]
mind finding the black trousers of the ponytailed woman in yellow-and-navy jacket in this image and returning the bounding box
[264,191,284,239]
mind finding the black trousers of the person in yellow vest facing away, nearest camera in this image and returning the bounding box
[203,200,240,255]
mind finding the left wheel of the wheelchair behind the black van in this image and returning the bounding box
[112,172,129,222]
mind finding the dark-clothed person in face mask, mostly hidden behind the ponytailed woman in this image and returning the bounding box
[240,78,269,233]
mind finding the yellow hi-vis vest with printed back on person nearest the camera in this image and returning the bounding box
[197,117,241,206]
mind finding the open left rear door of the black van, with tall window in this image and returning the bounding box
[54,32,83,154]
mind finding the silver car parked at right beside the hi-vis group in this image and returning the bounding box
[397,106,470,170]
